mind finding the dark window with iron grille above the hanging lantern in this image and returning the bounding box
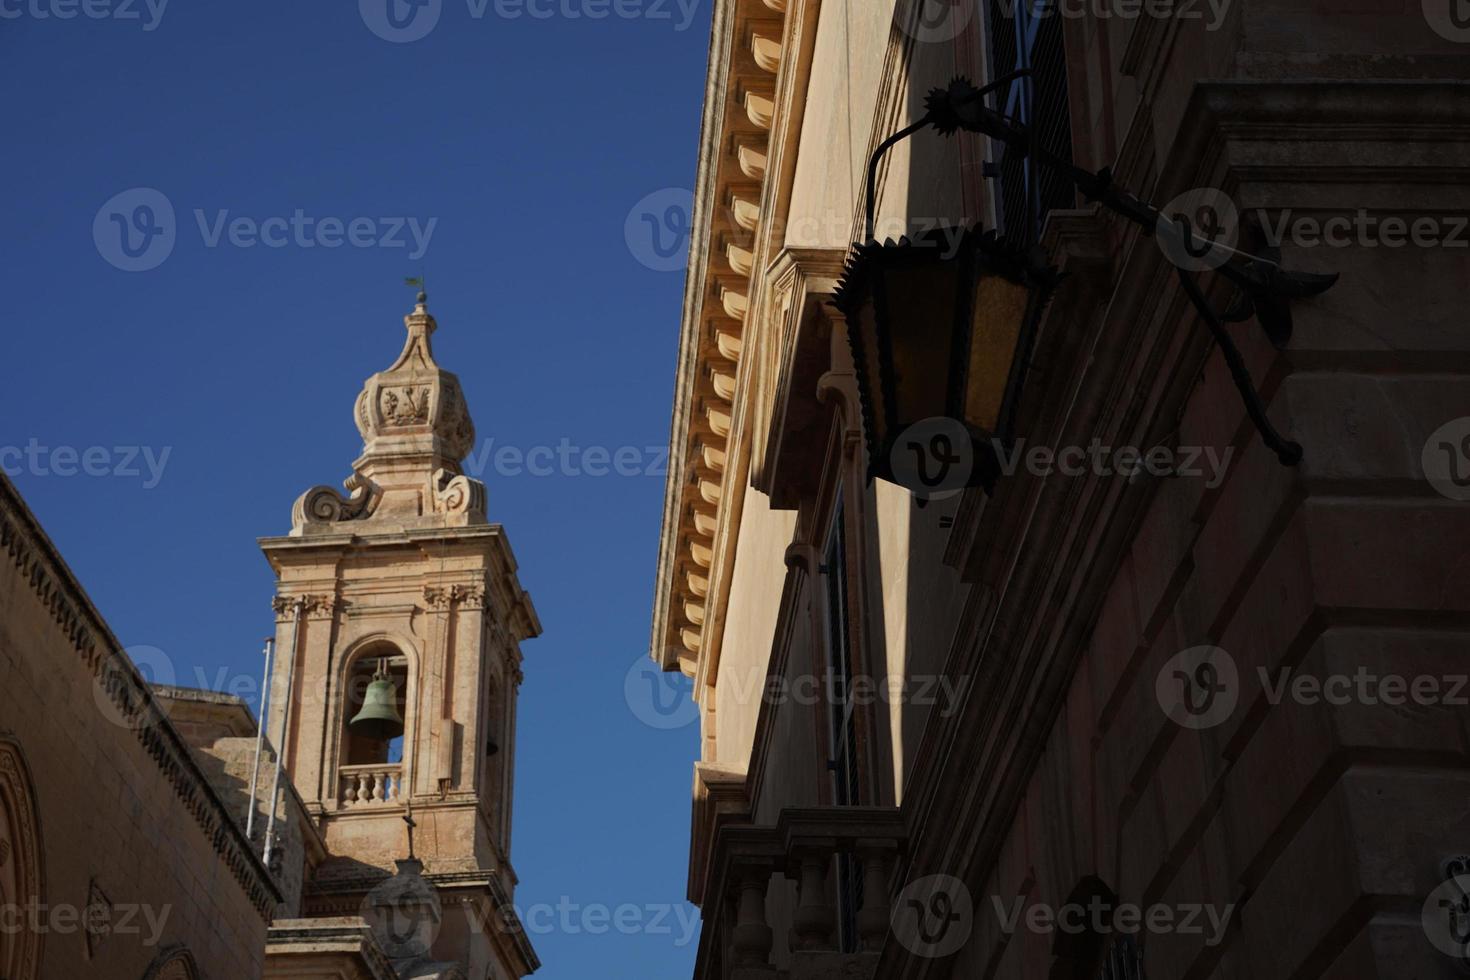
[979,0,1076,242]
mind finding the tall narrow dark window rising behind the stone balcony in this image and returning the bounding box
[822,501,861,952]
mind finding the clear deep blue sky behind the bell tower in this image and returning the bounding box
[0,0,710,980]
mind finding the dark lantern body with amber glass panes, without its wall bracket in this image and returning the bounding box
[833,226,1057,498]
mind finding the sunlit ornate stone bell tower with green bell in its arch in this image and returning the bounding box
[260,292,541,980]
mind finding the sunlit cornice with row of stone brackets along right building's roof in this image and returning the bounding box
[650,0,820,679]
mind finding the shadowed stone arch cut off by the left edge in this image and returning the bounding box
[0,735,46,980]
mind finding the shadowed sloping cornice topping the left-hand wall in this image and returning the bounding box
[0,475,281,921]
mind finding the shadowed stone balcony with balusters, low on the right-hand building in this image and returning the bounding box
[694,807,906,980]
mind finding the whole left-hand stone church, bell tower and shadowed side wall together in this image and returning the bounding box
[0,294,541,980]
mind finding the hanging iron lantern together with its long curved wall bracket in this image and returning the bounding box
[833,69,1338,502]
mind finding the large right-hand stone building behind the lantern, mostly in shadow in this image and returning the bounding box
[651,0,1470,980]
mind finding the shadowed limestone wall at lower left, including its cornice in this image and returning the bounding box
[0,478,276,980]
